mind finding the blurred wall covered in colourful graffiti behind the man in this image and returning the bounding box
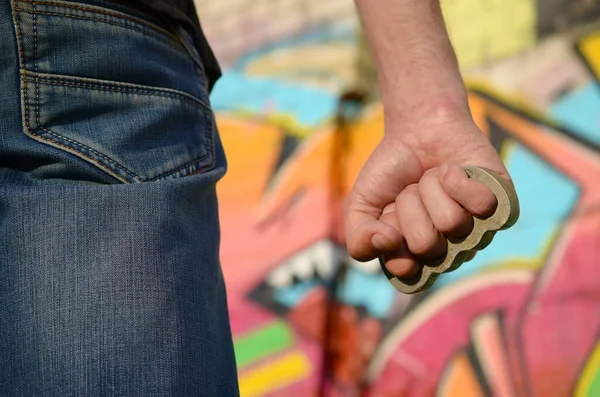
[197,0,600,397]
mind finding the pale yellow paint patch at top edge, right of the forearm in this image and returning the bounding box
[442,0,537,68]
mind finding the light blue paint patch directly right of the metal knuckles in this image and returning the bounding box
[435,145,579,288]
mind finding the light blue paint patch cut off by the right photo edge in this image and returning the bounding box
[549,83,600,145]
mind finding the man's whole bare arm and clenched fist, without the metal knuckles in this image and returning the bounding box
[344,0,510,277]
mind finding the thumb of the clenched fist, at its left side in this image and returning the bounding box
[344,193,402,262]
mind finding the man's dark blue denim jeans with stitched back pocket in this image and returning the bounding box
[0,0,238,397]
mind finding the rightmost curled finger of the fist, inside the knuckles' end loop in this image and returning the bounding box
[439,163,498,217]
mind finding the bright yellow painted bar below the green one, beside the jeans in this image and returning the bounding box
[239,350,311,397]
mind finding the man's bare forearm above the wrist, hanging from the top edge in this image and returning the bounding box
[355,0,468,118]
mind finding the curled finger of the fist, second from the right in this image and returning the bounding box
[419,169,474,238]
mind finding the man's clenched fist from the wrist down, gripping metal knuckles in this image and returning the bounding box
[344,110,509,277]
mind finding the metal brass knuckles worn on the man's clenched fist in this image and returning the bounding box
[379,165,520,294]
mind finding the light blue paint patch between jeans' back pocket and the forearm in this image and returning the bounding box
[211,71,338,128]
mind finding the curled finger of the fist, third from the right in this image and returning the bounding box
[396,184,447,259]
